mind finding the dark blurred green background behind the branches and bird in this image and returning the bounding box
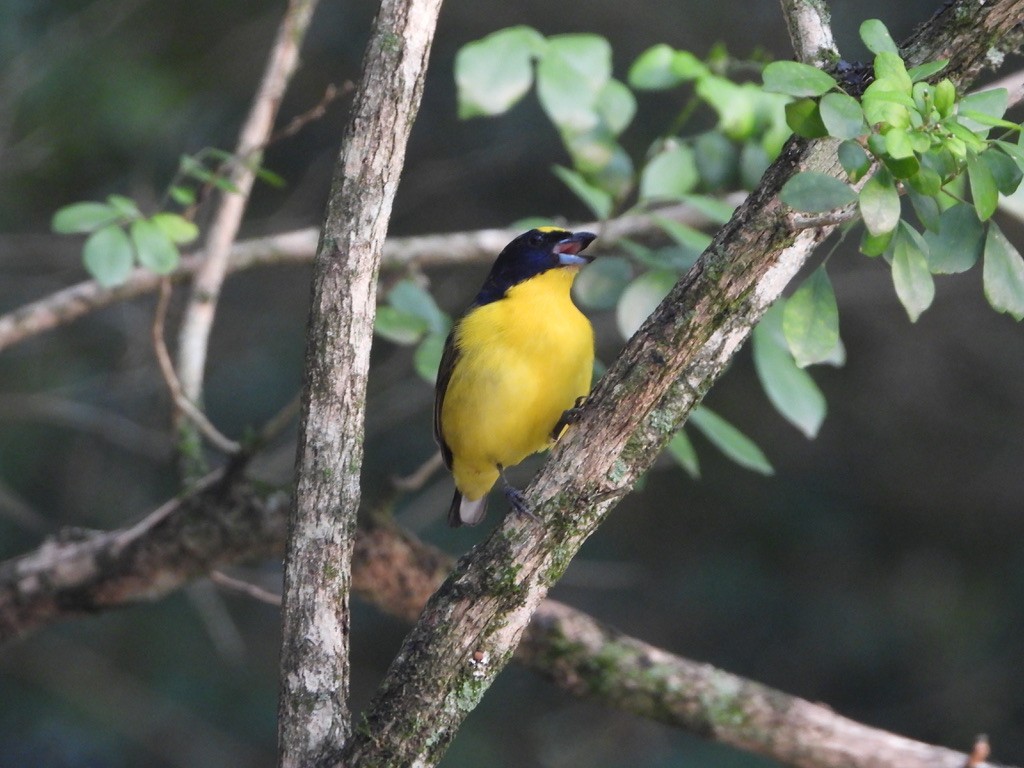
[0,0,1024,768]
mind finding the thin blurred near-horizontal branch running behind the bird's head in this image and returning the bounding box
[0,195,742,351]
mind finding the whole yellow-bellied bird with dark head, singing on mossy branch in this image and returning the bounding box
[434,226,596,526]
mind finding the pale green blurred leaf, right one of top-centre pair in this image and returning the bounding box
[537,34,611,131]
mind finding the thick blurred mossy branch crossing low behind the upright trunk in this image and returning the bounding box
[0,495,1007,768]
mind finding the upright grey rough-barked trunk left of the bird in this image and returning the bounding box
[278,0,440,768]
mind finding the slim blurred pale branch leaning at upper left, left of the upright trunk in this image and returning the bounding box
[177,0,317,403]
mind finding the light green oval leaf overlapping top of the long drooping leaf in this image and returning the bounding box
[782,266,839,368]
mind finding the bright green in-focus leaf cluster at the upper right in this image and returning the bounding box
[764,19,1024,321]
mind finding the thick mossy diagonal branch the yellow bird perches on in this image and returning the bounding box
[343,0,1024,766]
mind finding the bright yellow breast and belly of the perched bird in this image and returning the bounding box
[440,268,594,499]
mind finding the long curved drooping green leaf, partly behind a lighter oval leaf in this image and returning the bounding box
[753,303,826,438]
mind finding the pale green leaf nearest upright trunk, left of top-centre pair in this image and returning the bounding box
[455,27,545,119]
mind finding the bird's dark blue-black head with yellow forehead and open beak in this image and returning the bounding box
[473,226,597,306]
